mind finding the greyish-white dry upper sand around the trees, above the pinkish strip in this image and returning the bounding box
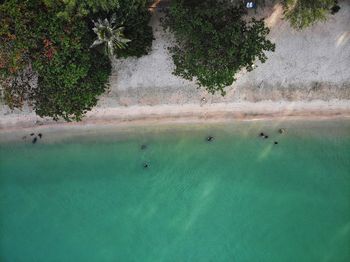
[106,0,350,106]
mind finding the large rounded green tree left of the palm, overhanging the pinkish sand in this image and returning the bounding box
[33,12,110,121]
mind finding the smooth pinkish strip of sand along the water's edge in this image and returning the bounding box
[0,100,350,133]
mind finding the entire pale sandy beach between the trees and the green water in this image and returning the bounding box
[0,1,350,132]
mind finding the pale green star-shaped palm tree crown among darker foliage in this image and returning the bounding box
[90,14,131,57]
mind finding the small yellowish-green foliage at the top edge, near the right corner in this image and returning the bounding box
[283,0,339,30]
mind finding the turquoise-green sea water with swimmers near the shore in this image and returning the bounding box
[0,121,350,262]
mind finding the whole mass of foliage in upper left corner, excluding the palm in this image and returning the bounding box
[0,0,153,121]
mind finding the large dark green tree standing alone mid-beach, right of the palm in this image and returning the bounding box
[165,0,275,95]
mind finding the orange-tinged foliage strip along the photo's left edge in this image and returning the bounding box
[0,1,38,109]
